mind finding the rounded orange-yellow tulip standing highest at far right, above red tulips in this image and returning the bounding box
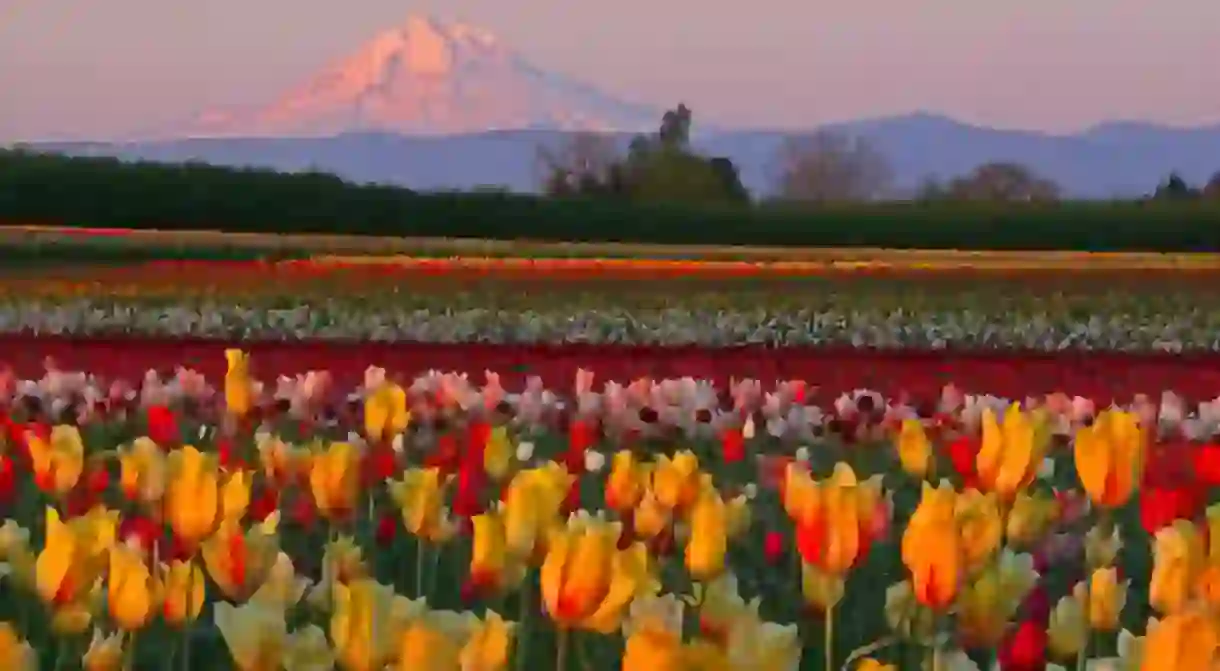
[1074,410,1144,509]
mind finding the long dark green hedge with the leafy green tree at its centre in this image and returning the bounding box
[0,148,1220,252]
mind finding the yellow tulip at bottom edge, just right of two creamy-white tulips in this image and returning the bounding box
[331,578,398,671]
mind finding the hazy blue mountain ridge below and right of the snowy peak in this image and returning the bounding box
[32,110,1220,199]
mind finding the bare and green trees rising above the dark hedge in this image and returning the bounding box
[538,104,1220,205]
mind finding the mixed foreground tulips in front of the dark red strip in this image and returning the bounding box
[0,350,1220,671]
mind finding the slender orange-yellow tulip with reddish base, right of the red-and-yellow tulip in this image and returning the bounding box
[902,482,965,610]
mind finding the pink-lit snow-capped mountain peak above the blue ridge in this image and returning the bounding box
[189,16,660,137]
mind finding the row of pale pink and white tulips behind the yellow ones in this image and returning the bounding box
[11,366,1220,446]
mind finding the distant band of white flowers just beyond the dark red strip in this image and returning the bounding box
[0,299,1220,353]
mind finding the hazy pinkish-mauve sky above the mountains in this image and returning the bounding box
[0,0,1220,140]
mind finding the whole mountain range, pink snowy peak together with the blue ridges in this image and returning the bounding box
[16,16,1220,198]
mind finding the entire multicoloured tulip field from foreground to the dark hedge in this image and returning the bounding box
[0,245,1220,671]
